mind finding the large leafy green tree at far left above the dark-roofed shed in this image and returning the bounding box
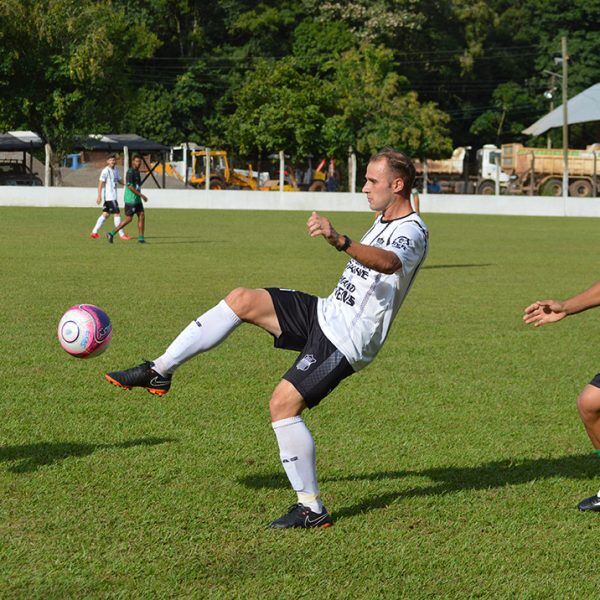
[0,0,159,183]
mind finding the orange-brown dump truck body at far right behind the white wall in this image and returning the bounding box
[501,144,600,198]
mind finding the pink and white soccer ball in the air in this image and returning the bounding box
[58,304,112,358]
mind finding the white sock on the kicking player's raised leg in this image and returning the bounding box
[152,300,242,376]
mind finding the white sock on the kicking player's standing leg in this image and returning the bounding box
[273,416,323,513]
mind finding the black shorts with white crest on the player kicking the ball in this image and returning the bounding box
[266,288,354,408]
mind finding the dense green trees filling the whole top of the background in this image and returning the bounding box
[0,0,600,159]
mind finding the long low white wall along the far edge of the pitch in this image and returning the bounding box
[0,186,600,217]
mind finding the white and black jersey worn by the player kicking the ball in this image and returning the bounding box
[317,213,429,371]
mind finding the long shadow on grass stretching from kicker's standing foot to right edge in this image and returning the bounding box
[239,454,600,518]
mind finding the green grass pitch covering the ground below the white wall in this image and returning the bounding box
[0,206,600,599]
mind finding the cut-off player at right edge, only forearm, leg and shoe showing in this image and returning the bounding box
[523,281,600,512]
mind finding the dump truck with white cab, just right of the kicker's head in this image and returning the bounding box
[415,144,510,195]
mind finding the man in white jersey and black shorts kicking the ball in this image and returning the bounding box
[106,149,428,529]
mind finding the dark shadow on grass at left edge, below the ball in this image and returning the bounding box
[0,438,176,473]
